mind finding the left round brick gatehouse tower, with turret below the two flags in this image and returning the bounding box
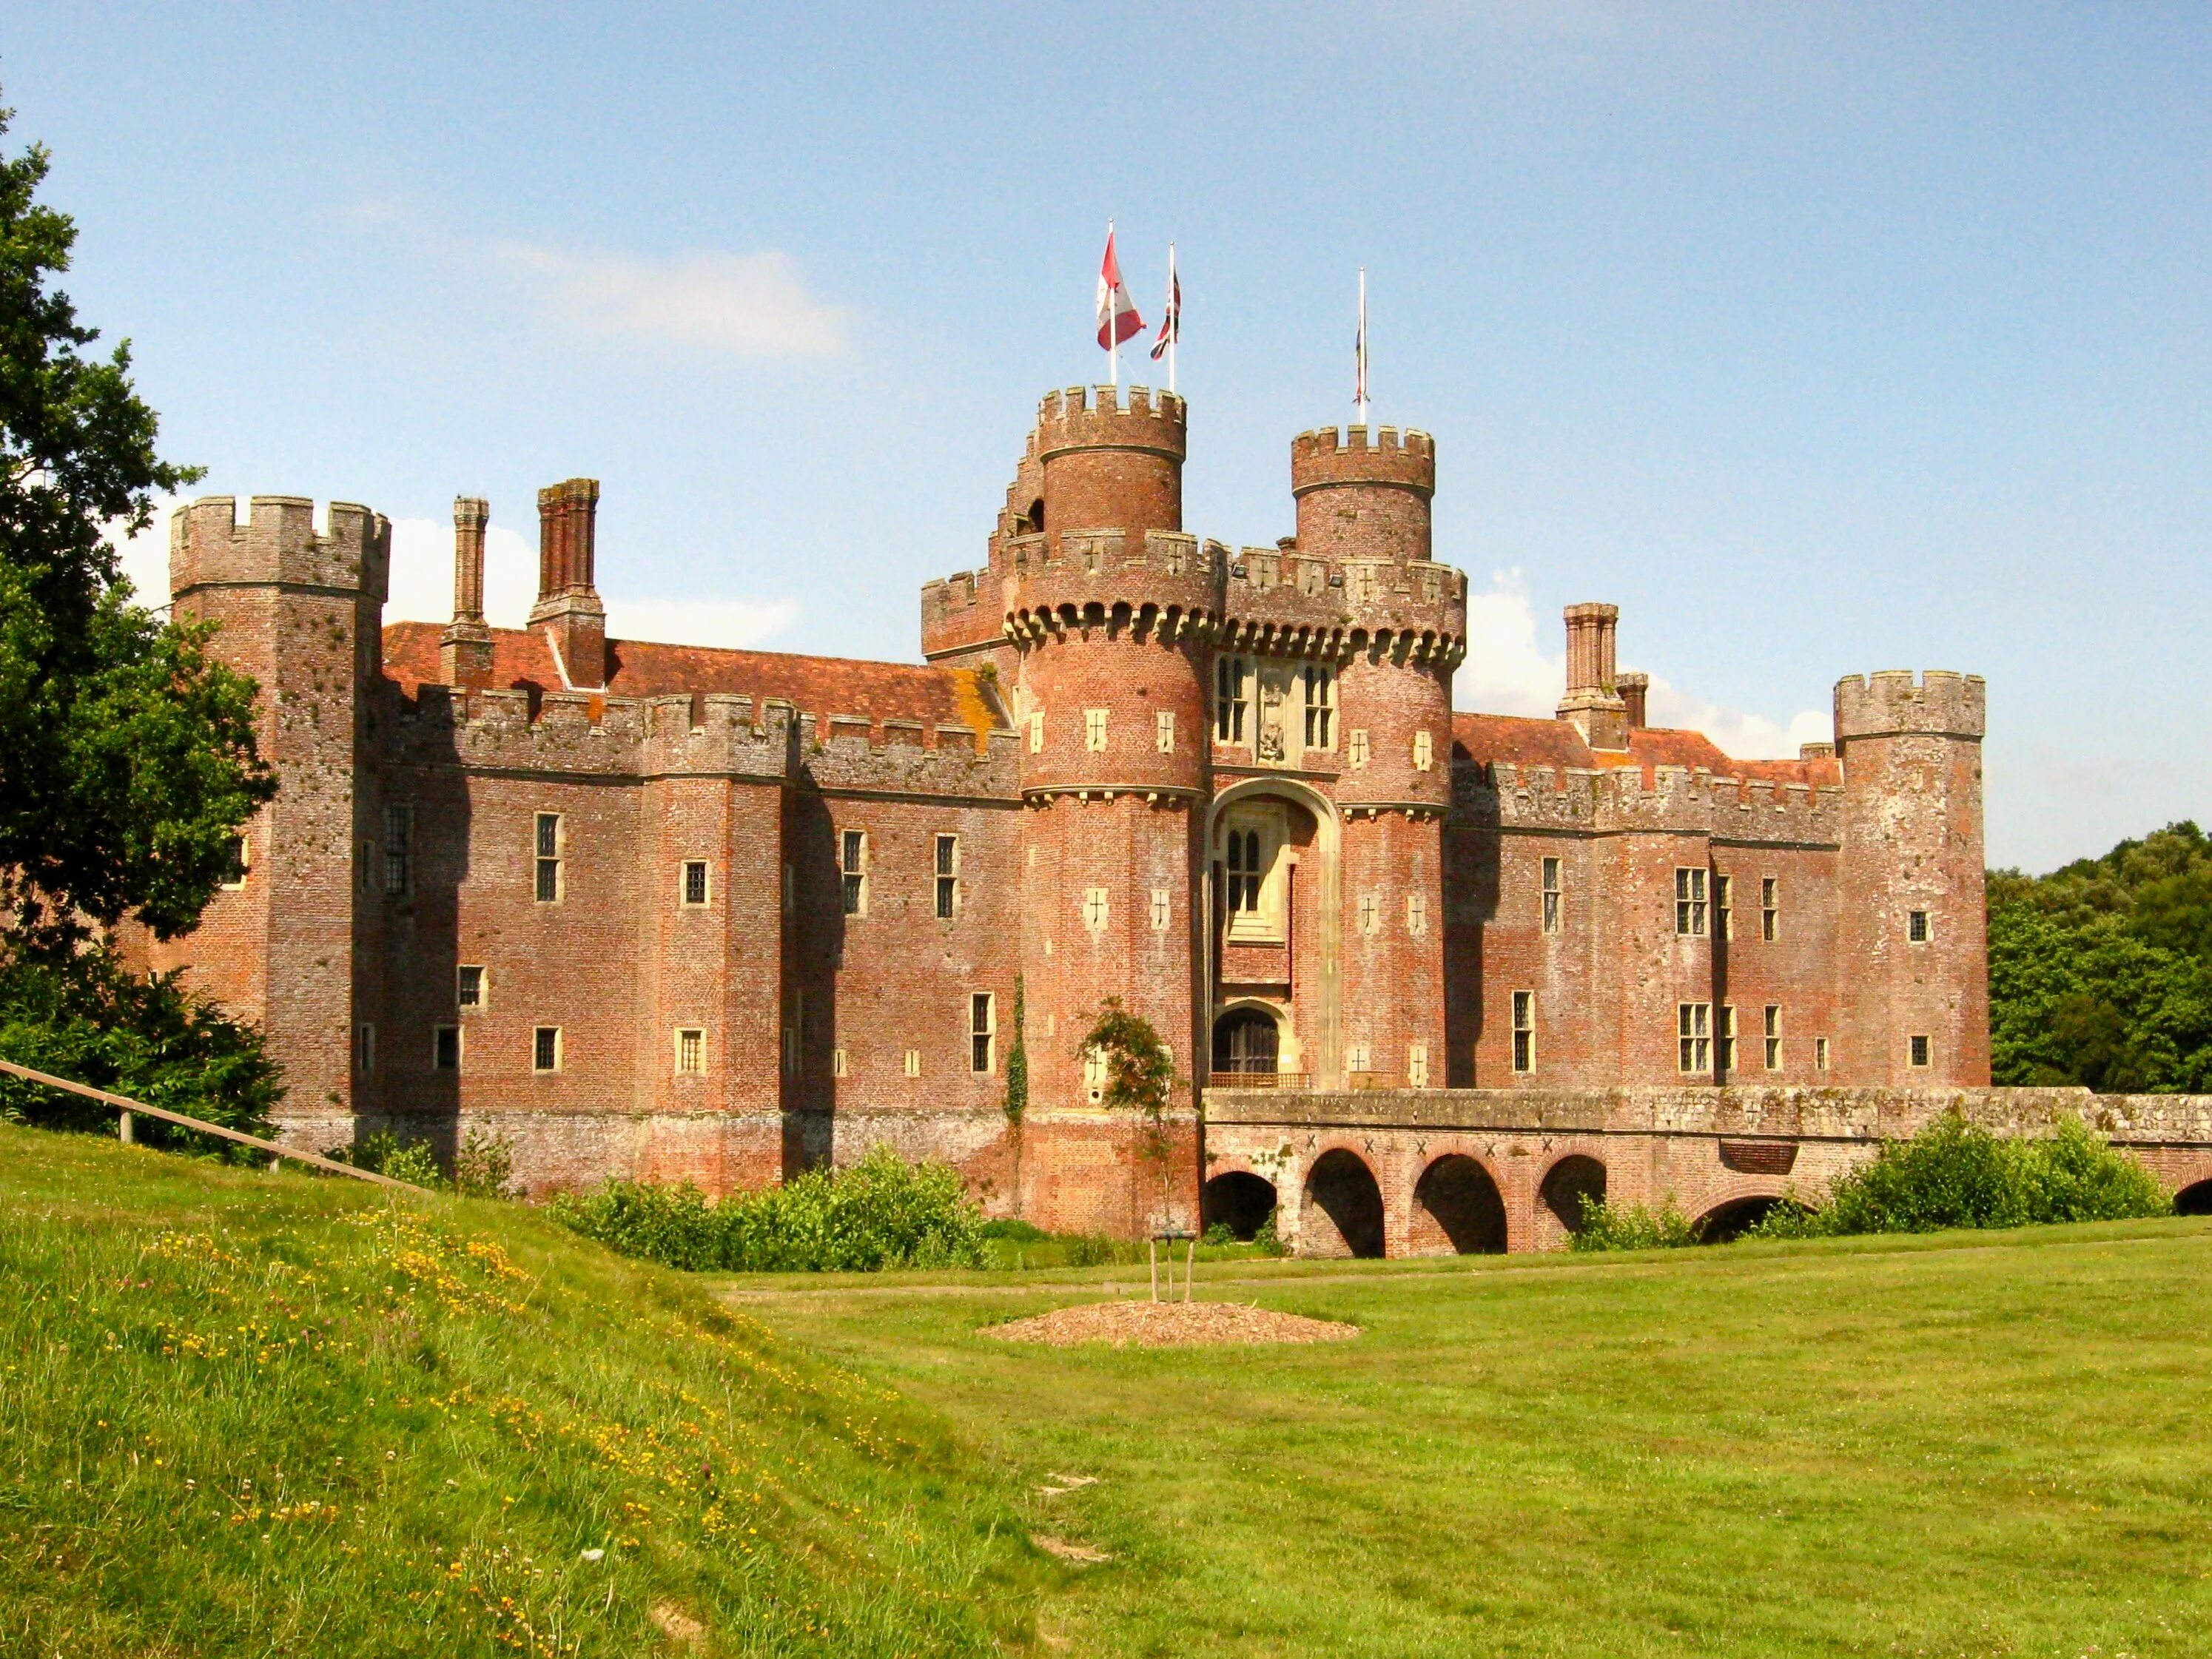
[1002,387,1221,1232]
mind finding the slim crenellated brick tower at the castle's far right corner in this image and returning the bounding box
[1836,668,1989,1086]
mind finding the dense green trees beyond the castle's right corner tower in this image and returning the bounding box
[1989,823,2212,1093]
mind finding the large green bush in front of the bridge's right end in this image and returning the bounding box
[1745,1111,2174,1239]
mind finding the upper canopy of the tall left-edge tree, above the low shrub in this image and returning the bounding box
[0,97,277,946]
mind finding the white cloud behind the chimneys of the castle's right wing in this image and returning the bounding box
[1453,571,1834,761]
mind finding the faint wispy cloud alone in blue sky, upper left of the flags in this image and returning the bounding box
[489,241,847,356]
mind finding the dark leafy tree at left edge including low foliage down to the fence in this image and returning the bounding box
[0,97,279,1137]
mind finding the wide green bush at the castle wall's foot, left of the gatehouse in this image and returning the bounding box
[553,1145,984,1272]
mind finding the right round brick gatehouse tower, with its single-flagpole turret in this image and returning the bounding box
[1290,427,1467,1086]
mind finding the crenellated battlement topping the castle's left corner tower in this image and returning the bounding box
[168,496,391,604]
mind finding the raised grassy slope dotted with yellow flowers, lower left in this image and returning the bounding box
[0,1126,1044,1655]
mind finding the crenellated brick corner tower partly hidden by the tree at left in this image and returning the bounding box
[150,496,391,1148]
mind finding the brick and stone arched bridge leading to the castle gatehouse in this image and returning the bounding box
[1203,1088,2212,1256]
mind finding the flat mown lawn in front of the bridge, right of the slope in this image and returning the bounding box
[730,1221,2212,1659]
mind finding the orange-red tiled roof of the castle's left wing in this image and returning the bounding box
[385,622,1009,734]
